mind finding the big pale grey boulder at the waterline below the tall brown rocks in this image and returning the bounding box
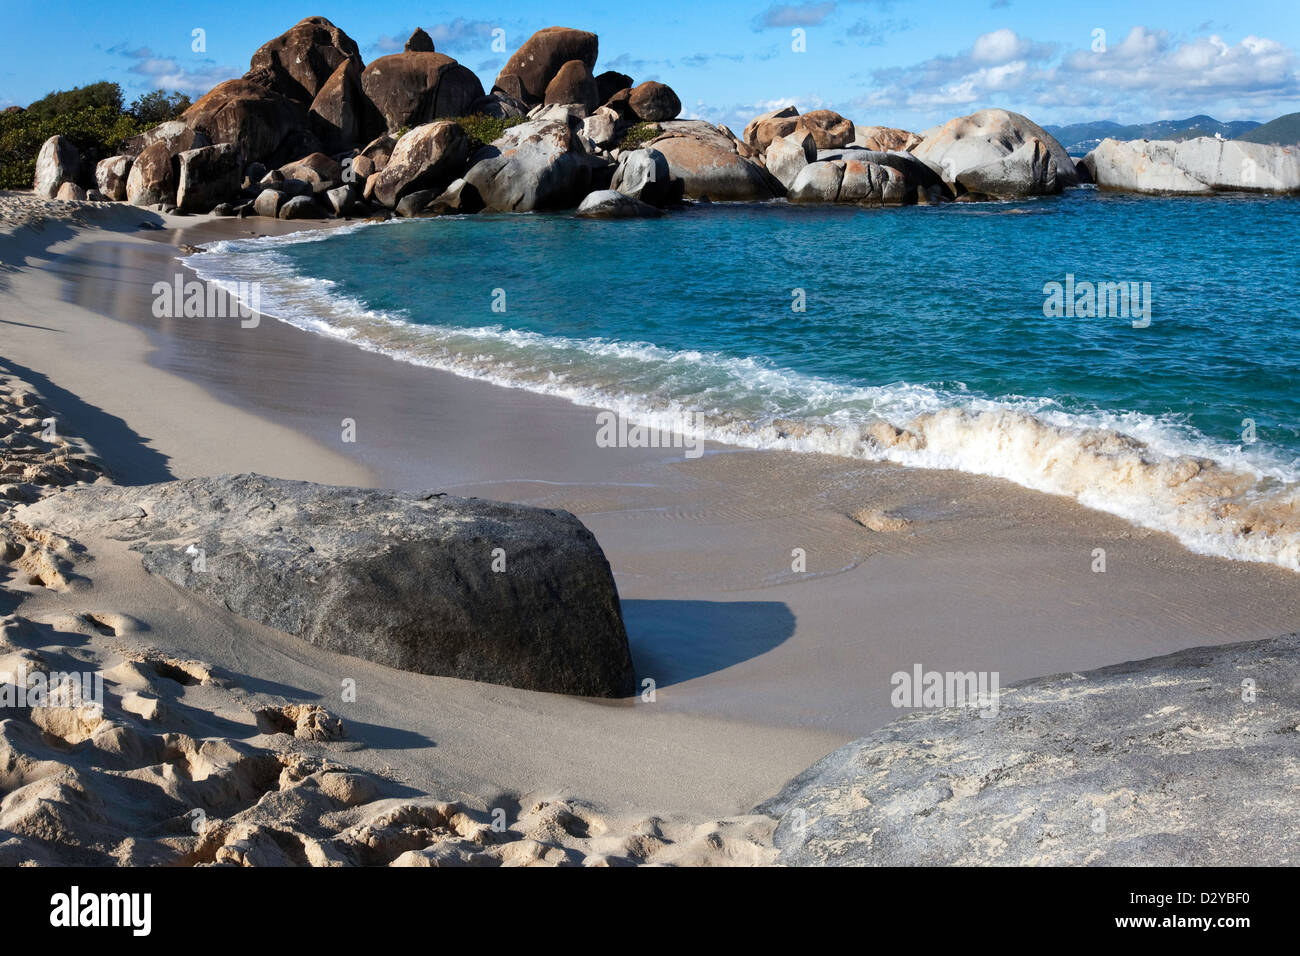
[464,113,595,212]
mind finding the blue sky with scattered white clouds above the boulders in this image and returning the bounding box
[0,0,1300,131]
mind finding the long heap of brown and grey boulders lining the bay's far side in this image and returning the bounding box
[34,17,1300,219]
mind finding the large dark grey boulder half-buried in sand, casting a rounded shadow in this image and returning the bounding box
[16,475,634,697]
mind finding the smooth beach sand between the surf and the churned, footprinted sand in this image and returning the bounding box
[0,191,1300,862]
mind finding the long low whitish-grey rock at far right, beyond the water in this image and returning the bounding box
[1082,137,1300,195]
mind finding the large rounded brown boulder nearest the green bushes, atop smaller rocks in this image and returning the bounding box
[185,77,315,166]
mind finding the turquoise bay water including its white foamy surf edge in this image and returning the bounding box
[187,190,1300,567]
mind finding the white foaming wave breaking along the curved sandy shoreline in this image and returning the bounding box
[183,230,1300,571]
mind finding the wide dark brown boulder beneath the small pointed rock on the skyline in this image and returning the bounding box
[361,53,484,131]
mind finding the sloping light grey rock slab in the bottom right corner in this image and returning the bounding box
[759,635,1300,866]
